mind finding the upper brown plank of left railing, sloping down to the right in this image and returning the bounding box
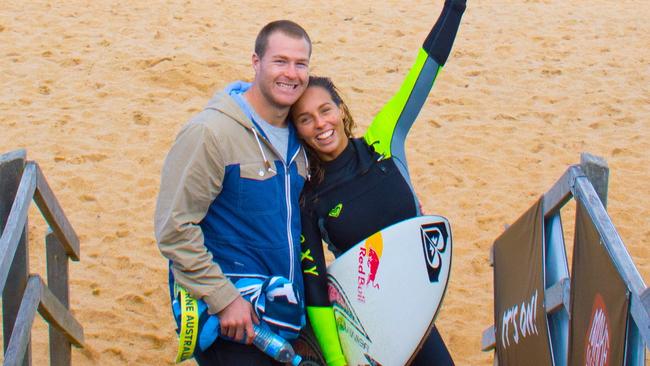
[29,162,79,261]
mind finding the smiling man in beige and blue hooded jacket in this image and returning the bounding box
[155,20,311,365]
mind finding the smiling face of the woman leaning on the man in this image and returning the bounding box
[291,86,348,161]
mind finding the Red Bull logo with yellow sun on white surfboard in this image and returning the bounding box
[357,232,384,302]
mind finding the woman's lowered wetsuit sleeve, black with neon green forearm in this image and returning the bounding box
[300,207,345,366]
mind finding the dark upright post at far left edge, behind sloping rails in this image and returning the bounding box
[0,149,31,366]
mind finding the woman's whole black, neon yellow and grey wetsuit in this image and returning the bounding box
[301,0,465,365]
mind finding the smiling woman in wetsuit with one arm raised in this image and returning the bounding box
[291,0,465,365]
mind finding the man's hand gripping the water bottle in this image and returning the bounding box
[217,296,259,344]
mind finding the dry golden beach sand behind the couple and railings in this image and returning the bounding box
[0,0,650,365]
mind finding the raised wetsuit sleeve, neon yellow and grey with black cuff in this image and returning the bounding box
[364,0,466,167]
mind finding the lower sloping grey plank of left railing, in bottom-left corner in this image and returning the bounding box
[3,276,42,366]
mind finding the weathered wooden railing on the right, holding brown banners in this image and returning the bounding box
[481,154,650,365]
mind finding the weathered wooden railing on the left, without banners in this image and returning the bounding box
[0,150,84,366]
